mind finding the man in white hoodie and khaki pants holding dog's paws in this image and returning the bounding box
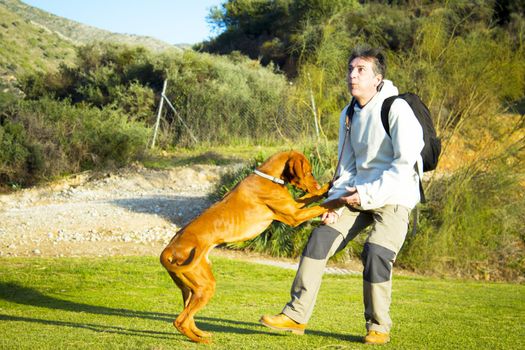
[260,48,424,344]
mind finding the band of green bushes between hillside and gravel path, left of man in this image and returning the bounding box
[0,43,305,186]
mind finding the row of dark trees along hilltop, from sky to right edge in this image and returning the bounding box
[202,0,525,76]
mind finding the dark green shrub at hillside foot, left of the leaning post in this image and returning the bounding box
[21,43,165,106]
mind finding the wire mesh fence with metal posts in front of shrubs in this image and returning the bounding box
[148,80,318,147]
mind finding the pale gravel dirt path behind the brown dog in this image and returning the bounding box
[0,165,237,257]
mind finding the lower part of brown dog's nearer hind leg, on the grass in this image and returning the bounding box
[173,260,215,343]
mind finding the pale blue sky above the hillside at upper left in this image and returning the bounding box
[22,0,225,44]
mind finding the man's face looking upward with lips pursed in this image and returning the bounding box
[346,57,383,102]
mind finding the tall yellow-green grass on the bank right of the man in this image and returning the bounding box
[399,120,525,280]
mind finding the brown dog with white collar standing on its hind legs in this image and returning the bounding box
[160,151,328,343]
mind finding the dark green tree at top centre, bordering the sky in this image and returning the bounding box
[201,0,357,76]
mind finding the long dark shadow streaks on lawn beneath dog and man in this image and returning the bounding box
[0,282,361,342]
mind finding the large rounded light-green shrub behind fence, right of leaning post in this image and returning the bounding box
[158,51,310,146]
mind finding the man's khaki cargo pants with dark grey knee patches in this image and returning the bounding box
[283,205,410,333]
